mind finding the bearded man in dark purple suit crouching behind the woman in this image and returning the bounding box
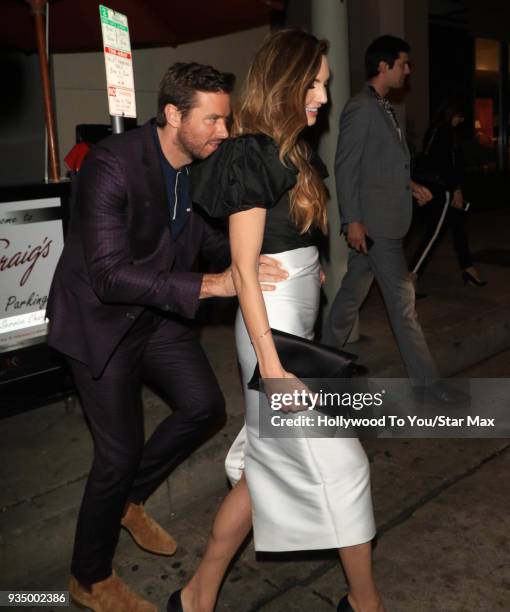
[48,63,286,612]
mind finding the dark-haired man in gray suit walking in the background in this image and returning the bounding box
[324,36,438,385]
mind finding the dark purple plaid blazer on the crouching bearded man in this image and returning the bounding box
[47,122,228,377]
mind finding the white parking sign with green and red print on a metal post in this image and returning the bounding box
[99,5,136,134]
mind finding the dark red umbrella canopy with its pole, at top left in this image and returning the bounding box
[0,0,285,181]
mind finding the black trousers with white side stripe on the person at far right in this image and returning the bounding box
[409,192,473,276]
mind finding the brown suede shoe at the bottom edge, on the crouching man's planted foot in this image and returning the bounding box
[69,572,158,612]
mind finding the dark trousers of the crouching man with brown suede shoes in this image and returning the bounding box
[69,311,225,585]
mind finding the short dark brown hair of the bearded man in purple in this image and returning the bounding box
[156,62,236,127]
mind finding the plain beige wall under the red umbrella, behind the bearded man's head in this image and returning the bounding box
[52,26,269,174]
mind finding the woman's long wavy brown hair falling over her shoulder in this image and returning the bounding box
[232,29,328,233]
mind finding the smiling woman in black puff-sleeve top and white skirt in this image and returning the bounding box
[168,29,383,612]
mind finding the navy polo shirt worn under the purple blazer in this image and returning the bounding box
[153,124,191,240]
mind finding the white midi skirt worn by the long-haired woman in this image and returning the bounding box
[226,247,375,552]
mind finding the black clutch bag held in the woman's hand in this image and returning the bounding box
[248,329,357,391]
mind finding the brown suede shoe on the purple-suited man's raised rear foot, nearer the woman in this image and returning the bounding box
[121,504,177,556]
